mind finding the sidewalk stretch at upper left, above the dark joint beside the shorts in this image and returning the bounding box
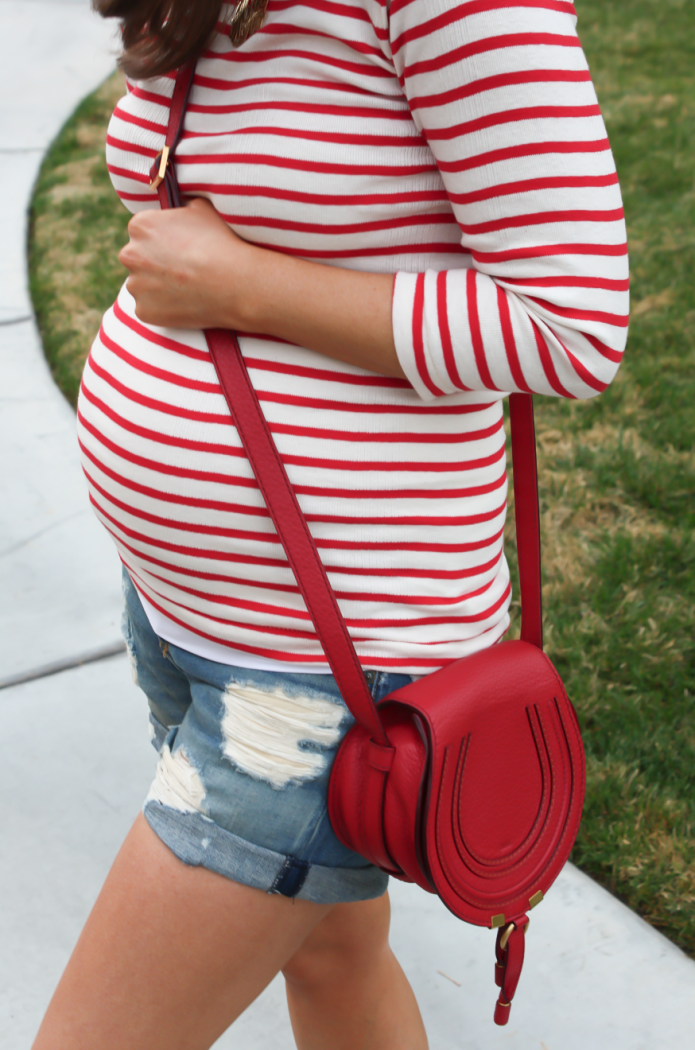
[0,0,125,679]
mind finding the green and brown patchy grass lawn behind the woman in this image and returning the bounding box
[30,0,695,956]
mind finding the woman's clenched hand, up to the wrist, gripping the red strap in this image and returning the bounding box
[119,197,261,329]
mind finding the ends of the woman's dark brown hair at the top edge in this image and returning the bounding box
[92,0,224,79]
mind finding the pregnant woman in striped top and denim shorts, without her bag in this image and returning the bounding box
[35,0,628,1050]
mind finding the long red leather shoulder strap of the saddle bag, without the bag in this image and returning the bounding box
[150,63,543,747]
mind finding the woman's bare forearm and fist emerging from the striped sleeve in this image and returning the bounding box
[119,198,405,379]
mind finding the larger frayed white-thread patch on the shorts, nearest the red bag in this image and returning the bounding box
[222,684,345,788]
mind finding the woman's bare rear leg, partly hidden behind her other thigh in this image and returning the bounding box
[282,896,427,1050]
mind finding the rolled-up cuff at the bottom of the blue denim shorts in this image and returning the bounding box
[143,801,388,904]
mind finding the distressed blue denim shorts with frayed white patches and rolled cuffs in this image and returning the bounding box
[123,572,413,904]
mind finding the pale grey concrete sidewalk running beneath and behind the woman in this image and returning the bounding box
[0,0,695,1050]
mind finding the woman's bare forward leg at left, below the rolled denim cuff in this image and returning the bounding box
[34,816,331,1050]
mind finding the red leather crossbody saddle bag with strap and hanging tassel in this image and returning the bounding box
[151,64,585,1025]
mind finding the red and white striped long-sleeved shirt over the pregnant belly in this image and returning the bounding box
[79,0,628,673]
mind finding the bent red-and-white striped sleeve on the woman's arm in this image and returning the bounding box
[389,0,629,400]
